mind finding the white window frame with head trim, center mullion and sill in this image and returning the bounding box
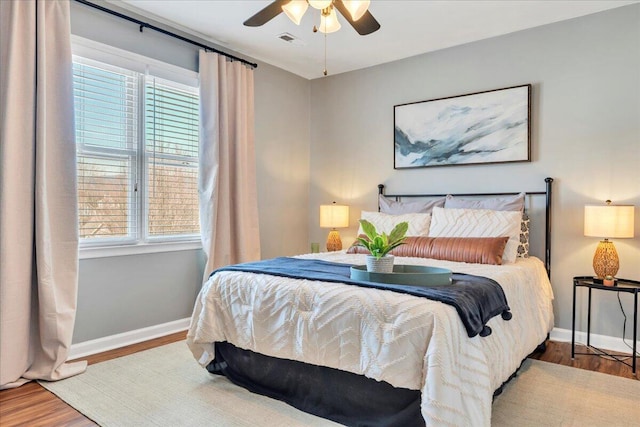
[71,35,202,259]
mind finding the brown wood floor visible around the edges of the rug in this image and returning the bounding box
[0,338,638,427]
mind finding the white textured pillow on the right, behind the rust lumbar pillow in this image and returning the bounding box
[429,207,522,263]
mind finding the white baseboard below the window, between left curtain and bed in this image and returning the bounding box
[68,318,191,360]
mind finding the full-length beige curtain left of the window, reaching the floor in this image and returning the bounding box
[0,0,86,388]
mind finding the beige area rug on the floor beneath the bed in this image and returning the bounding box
[41,342,640,427]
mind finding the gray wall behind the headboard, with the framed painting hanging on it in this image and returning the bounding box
[309,4,640,338]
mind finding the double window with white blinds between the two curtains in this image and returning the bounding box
[73,46,200,254]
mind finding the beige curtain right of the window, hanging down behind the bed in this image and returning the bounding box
[199,51,260,278]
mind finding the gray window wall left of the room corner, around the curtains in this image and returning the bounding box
[71,2,310,343]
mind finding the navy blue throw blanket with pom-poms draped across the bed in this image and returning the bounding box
[211,257,511,337]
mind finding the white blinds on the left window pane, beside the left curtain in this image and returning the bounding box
[73,60,138,240]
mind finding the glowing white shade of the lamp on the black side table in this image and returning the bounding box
[584,205,634,239]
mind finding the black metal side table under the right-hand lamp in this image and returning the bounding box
[571,276,640,374]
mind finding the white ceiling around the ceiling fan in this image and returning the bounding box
[111,0,639,79]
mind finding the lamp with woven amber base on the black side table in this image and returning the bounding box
[584,200,634,279]
